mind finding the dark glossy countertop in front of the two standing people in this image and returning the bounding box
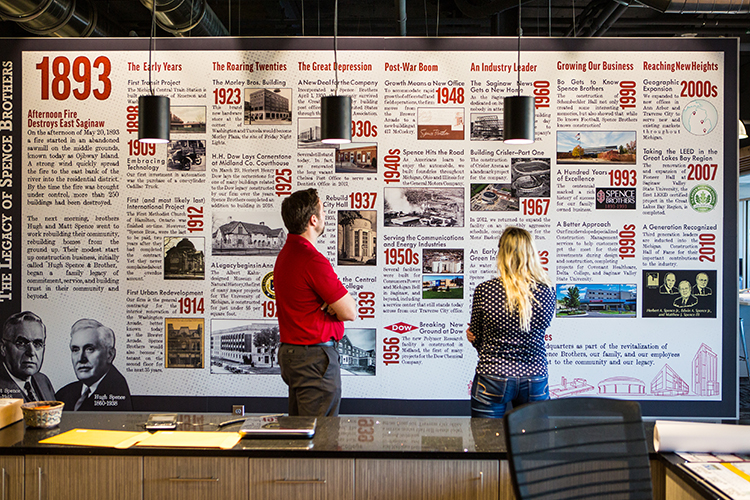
[0,412,658,460]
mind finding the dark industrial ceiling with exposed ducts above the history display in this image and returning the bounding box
[0,0,750,155]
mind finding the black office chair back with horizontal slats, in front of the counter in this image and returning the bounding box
[504,398,653,500]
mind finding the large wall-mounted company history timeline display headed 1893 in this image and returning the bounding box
[0,38,738,417]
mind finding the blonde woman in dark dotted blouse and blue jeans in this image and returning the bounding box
[466,226,555,418]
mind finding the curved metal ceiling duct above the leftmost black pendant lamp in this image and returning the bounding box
[141,0,229,36]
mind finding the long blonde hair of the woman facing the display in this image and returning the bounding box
[497,226,552,331]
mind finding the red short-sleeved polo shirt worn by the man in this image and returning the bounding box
[273,234,348,345]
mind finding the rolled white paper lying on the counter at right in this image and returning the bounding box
[654,420,750,453]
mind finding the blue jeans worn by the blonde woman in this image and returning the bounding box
[471,373,549,418]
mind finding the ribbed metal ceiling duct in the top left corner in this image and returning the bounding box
[0,0,127,37]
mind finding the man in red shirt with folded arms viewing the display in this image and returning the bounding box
[273,188,357,417]
